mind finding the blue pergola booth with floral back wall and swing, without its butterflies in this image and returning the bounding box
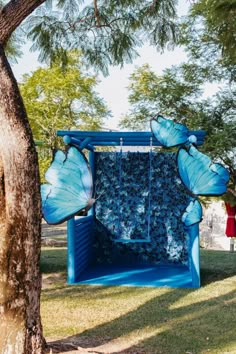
[58,131,205,288]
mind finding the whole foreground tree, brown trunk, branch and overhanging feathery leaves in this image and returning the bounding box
[0,0,179,354]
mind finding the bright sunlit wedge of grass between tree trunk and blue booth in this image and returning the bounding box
[42,286,171,337]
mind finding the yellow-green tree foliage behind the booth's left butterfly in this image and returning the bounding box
[20,51,110,180]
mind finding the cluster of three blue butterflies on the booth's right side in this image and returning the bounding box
[151,115,230,226]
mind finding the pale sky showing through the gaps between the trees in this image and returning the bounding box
[10,0,217,129]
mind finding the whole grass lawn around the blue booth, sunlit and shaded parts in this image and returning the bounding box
[41,248,236,354]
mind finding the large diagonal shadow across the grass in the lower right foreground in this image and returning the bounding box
[46,289,236,354]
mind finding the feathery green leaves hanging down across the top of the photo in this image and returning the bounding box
[24,0,178,74]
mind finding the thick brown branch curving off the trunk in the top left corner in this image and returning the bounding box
[0,0,45,46]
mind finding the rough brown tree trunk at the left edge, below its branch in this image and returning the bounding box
[0,46,44,354]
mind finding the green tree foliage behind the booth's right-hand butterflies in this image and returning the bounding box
[121,67,236,204]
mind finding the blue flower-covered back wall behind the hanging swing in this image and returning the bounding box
[94,152,190,265]
